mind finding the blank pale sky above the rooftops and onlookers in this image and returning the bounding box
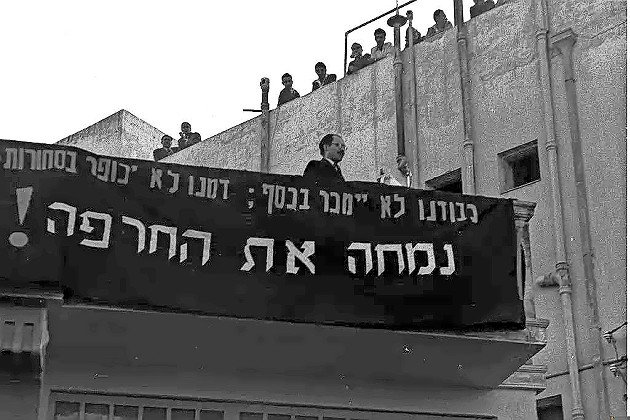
[0,0,473,146]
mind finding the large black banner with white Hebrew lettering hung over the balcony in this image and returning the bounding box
[0,141,524,329]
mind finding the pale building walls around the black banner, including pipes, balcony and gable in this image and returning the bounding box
[0,0,627,420]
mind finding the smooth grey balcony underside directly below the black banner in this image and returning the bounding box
[47,305,549,388]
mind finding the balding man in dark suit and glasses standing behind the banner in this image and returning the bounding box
[304,134,346,183]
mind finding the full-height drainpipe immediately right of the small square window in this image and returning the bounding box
[536,0,584,414]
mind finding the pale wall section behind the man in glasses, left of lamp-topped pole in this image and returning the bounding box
[164,58,396,181]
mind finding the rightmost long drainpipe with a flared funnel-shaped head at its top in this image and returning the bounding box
[551,28,610,419]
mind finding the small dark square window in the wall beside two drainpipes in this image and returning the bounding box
[499,140,540,193]
